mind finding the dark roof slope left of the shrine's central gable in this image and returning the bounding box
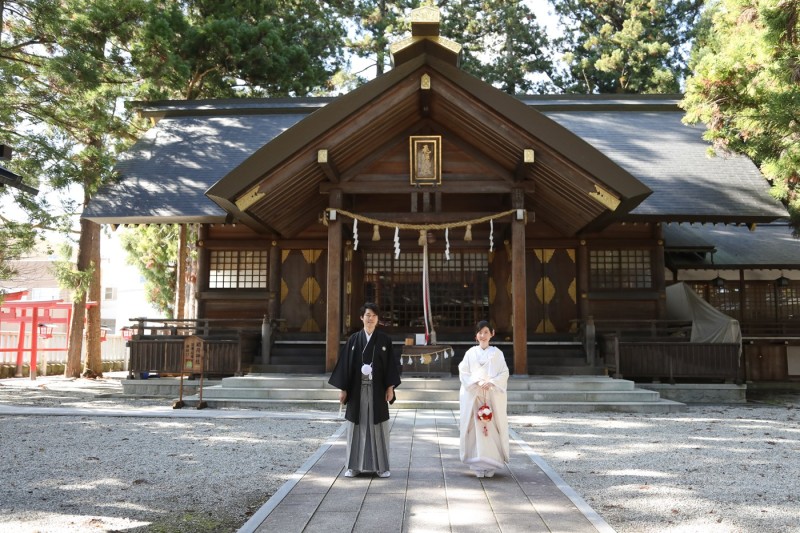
[83,111,310,224]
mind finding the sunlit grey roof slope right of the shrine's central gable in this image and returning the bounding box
[541,111,786,222]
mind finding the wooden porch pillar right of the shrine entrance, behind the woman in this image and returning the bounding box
[511,189,528,376]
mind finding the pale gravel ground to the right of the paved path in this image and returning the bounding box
[511,404,800,533]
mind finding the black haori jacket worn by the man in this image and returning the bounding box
[328,329,400,424]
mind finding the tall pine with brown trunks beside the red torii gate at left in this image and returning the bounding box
[0,0,144,377]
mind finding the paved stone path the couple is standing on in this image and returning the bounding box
[239,410,614,533]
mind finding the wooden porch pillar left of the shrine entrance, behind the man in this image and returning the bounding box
[325,189,342,372]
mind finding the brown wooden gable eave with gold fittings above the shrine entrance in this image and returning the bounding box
[206,53,650,237]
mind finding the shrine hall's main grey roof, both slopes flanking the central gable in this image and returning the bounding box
[84,95,786,223]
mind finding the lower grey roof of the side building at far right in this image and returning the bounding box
[664,222,800,270]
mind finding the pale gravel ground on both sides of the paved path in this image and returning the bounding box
[0,377,800,533]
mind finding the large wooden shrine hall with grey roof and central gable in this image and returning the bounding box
[83,8,800,382]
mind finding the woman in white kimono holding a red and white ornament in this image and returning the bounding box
[458,320,509,477]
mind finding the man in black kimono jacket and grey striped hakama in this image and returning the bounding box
[328,303,400,477]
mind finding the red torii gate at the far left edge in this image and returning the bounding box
[0,300,97,380]
